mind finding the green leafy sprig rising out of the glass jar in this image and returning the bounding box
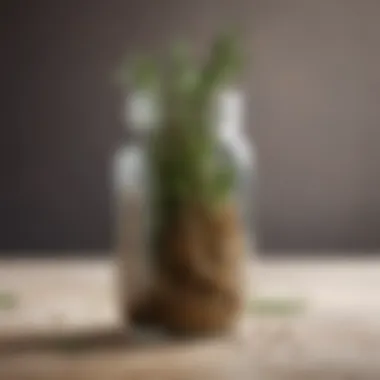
[119,34,245,214]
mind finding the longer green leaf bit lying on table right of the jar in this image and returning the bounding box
[248,297,306,316]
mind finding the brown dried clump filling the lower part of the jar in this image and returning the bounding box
[132,202,245,335]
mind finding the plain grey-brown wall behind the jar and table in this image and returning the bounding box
[0,0,380,251]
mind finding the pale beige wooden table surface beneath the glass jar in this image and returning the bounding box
[0,259,380,380]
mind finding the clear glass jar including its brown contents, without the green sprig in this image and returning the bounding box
[114,89,255,333]
